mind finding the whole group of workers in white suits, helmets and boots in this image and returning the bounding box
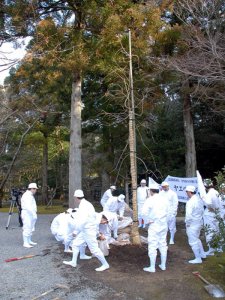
[21,179,225,273]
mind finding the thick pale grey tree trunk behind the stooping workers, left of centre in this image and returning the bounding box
[69,74,82,208]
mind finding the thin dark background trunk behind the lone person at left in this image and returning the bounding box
[42,134,48,205]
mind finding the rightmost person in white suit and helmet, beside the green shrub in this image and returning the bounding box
[202,179,221,256]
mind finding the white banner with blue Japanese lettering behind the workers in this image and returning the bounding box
[164,175,198,203]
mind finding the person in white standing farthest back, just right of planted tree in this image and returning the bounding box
[137,179,149,228]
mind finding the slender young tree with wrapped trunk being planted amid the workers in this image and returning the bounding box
[129,30,141,245]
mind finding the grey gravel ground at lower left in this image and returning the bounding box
[0,213,116,300]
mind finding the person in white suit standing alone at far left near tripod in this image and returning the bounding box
[21,183,38,248]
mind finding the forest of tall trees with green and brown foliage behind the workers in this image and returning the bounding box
[0,0,225,209]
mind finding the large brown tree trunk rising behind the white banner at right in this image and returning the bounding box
[183,80,197,177]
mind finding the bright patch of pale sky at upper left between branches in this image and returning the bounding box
[0,40,28,85]
